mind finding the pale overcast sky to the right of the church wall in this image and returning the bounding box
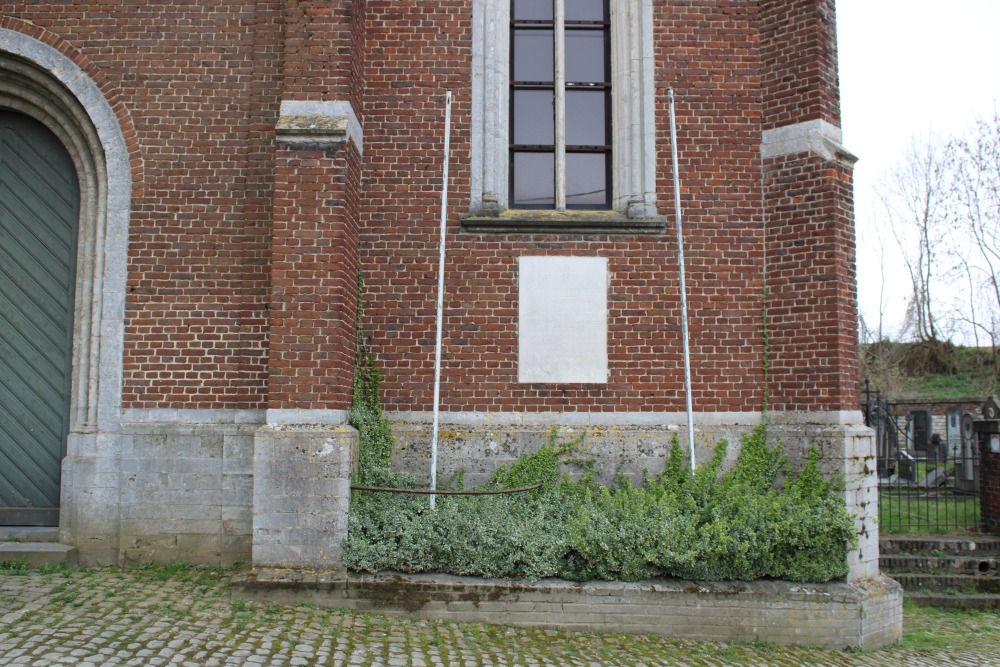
[837,0,1000,342]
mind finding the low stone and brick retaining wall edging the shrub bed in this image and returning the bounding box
[233,569,902,649]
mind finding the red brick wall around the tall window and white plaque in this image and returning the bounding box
[362,0,763,411]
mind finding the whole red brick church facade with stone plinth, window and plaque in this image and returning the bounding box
[0,0,878,596]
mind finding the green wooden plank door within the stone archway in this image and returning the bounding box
[0,110,80,526]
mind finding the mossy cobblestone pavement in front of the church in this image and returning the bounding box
[0,568,1000,667]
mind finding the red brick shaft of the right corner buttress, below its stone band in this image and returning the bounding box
[765,155,859,410]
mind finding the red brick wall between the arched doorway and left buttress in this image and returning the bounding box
[0,0,282,407]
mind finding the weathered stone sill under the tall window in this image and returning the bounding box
[462,209,666,239]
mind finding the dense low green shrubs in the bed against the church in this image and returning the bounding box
[345,426,855,582]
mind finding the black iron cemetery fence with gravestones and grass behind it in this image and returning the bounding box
[862,381,981,533]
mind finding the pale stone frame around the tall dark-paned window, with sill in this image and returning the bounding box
[463,0,663,233]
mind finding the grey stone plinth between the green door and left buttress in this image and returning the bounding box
[59,409,264,566]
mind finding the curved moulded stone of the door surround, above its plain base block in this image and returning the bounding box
[0,28,132,438]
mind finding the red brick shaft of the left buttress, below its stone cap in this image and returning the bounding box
[267,144,360,410]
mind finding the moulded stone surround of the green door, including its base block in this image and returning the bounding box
[0,28,131,562]
